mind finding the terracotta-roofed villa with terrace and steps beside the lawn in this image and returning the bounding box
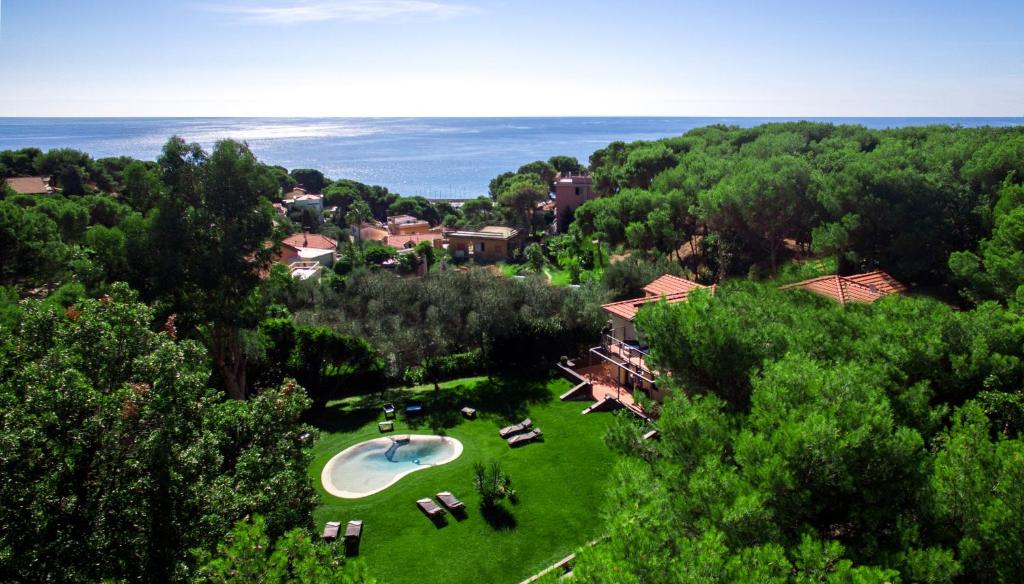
[562,274,717,418]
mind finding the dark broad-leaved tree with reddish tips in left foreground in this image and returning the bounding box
[0,285,314,581]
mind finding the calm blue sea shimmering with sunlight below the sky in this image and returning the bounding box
[0,117,1024,199]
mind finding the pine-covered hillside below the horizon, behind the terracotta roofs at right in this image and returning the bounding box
[575,122,1024,280]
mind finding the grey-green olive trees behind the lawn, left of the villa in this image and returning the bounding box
[296,268,603,382]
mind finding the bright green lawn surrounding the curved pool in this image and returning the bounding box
[309,378,614,584]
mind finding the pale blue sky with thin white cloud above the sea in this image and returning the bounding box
[0,0,1024,116]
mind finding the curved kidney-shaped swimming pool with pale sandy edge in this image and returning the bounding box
[321,434,462,499]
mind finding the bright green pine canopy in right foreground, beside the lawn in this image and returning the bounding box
[574,283,1024,582]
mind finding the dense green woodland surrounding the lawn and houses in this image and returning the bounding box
[0,123,1024,583]
